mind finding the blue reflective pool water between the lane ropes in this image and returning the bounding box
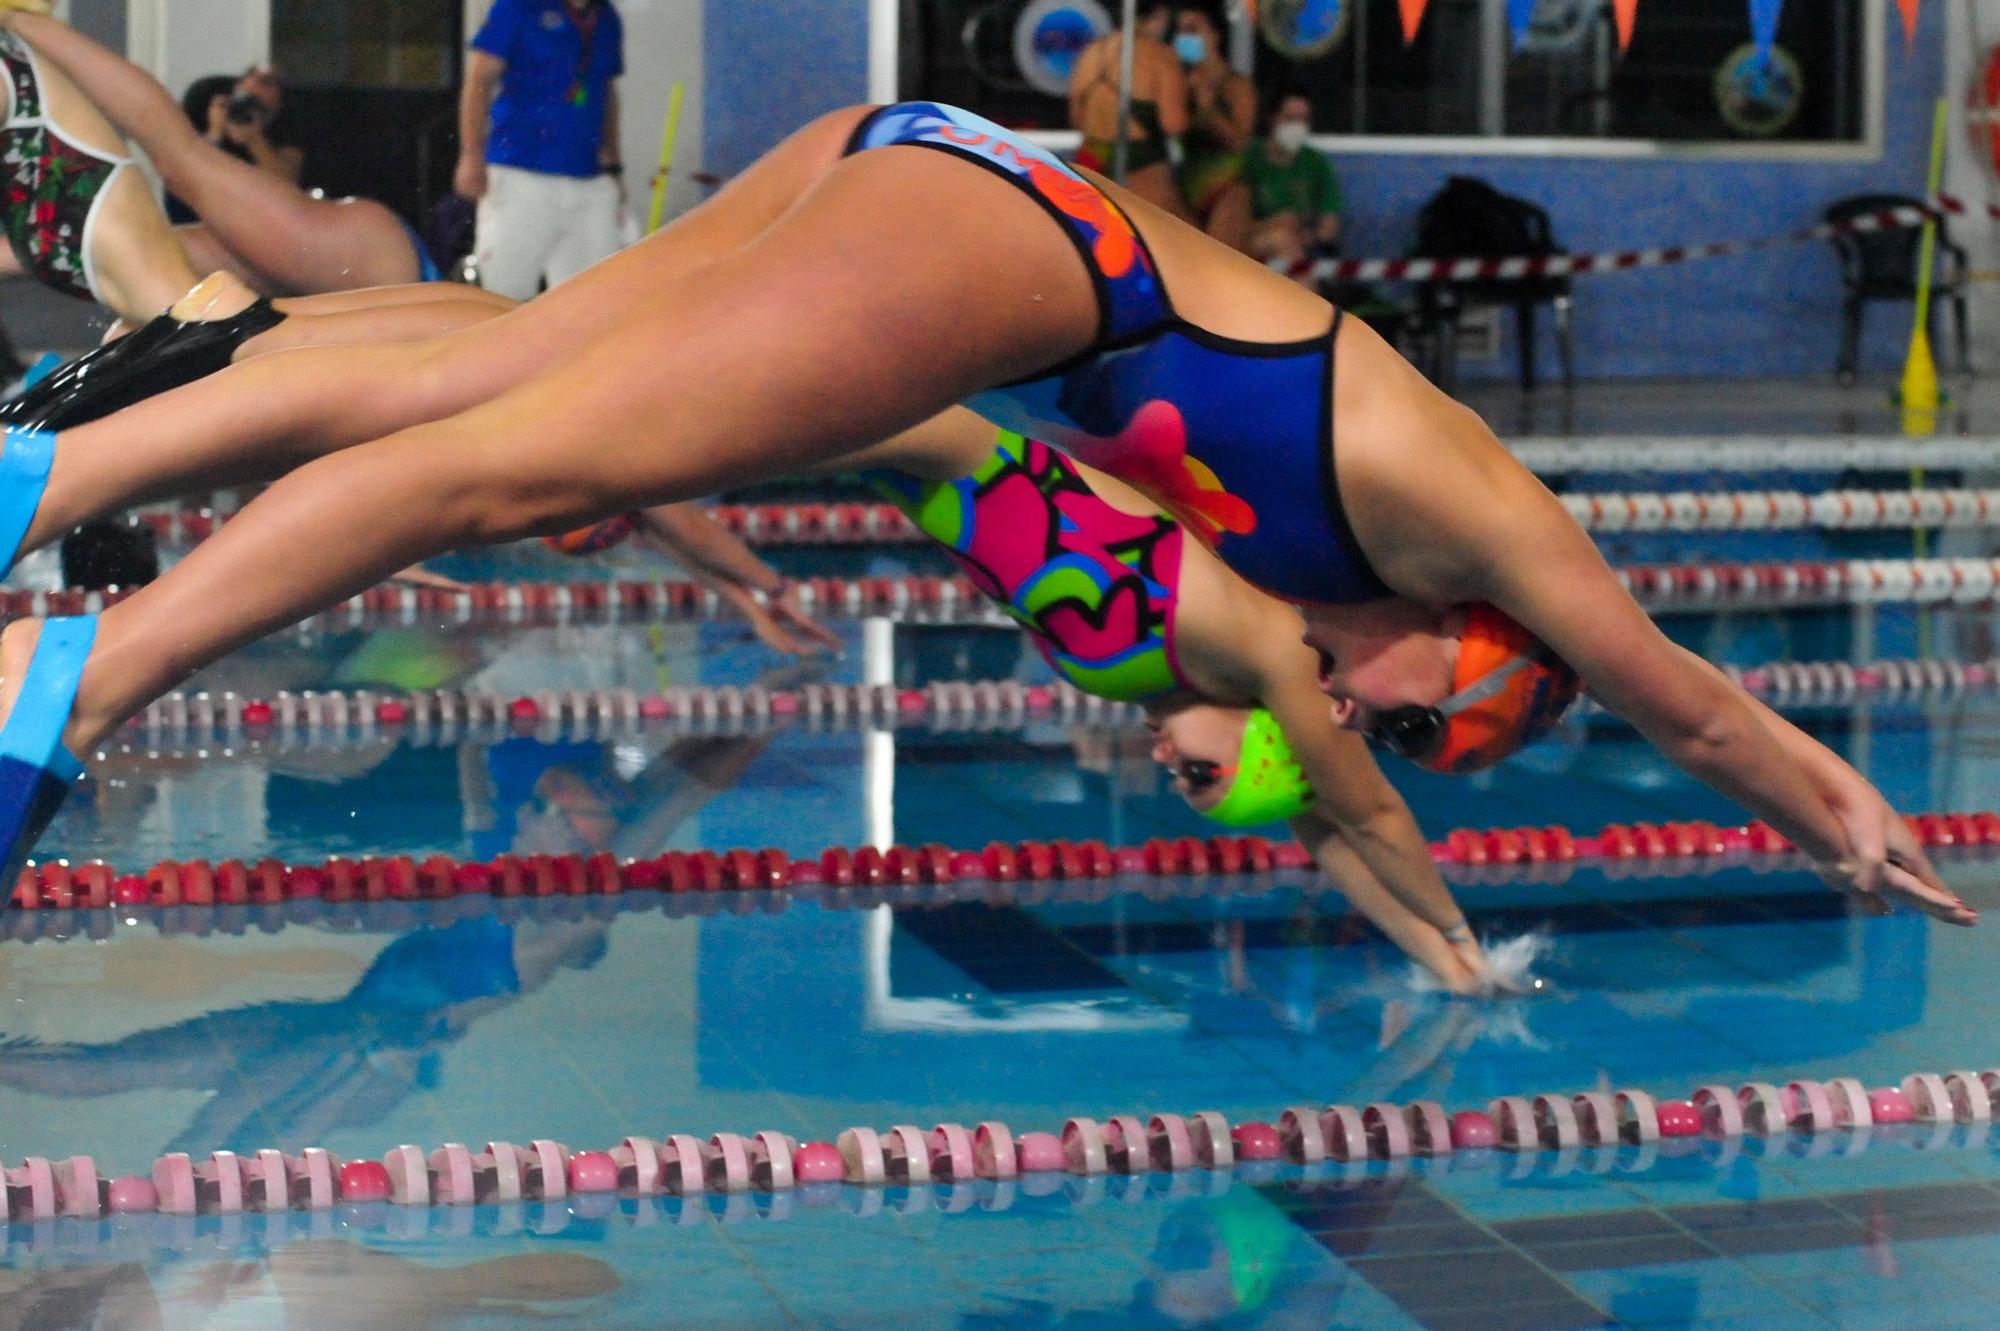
[0,535,2000,1331]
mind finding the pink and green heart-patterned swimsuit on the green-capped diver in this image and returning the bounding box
[868,432,1186,701]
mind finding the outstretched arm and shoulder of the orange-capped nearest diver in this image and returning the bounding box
[1336,362,1978,923]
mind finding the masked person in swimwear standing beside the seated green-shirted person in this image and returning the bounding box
[1174,4,1256,250]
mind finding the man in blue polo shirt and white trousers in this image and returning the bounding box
[452,0,624,300]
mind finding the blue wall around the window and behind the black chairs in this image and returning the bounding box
[704,0,1956,376]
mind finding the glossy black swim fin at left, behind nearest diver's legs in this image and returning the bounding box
[0,300,284,430]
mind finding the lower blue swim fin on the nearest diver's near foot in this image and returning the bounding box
[0,616,98,897]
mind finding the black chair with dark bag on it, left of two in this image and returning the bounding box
[1412,176,1576,390]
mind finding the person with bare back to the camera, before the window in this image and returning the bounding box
[1070,0,1188,222]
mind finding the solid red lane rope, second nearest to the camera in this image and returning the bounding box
[10,811,2000,909]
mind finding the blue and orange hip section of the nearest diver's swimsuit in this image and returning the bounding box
[848,102,1174,344]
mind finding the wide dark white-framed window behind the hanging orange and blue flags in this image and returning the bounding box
[874,0,1888,156]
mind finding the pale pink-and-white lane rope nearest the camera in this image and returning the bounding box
[0,1069,2000,1223]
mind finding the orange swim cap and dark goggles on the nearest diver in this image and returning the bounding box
[1368,602,1578,775]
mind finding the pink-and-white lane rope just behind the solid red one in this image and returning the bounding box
[98,658,2000,755]
